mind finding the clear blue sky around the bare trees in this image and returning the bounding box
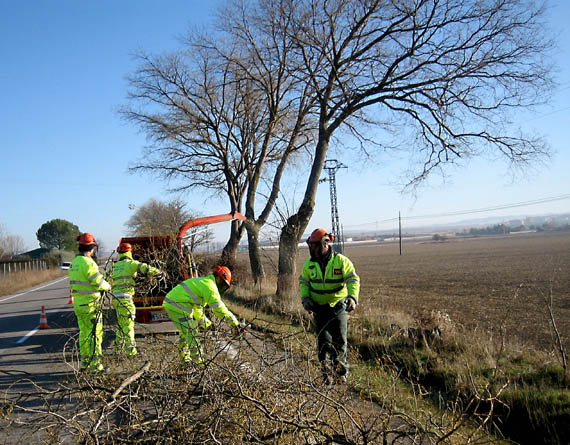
[0,0,570,250]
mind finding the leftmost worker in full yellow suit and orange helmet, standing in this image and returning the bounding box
[69,233,111,373]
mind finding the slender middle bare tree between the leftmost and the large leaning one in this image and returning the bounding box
[210,1,316,283]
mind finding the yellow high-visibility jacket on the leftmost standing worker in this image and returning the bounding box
[69,254,111,304]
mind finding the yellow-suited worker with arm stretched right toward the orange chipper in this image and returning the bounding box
[112,243,162,357]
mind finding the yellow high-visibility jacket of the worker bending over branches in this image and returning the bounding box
[163,275,239,326]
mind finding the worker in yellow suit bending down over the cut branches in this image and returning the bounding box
[162,266,243,363]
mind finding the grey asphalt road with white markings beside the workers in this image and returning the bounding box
[0,276,177,445]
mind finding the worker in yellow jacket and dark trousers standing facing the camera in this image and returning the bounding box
[299,229,360,383]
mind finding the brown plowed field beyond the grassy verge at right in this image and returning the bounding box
[340,232,570,350]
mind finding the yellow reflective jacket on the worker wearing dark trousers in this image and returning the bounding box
[299,253,360,307]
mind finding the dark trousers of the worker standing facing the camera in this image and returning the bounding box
[313,300,348,375]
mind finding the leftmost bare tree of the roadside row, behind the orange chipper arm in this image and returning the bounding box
[122,47,248,262]
